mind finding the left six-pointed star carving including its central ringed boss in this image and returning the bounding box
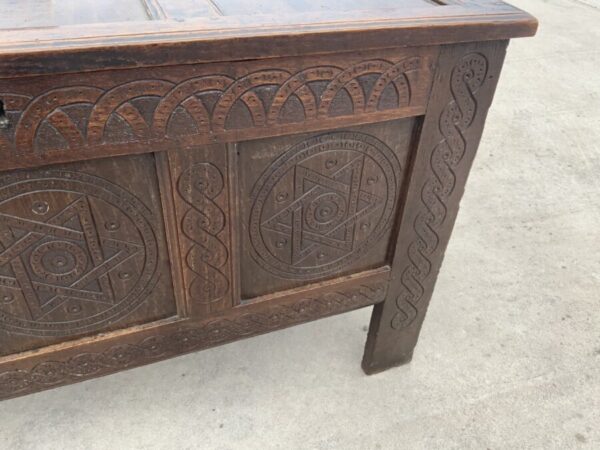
[0,196,143,320]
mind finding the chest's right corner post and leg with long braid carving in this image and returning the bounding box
[363,41,507,373]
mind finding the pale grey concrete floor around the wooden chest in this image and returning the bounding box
[0,0,600,450]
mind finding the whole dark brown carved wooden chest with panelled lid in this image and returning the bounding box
[0,0,537,398]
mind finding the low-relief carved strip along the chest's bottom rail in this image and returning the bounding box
[0,281,387,399]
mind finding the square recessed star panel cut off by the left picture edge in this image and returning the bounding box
[0,155,175,354]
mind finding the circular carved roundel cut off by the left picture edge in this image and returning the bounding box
[0,170,158,336]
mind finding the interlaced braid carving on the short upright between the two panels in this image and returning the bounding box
[177,163,229,303]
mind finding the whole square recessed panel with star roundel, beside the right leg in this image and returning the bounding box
[238,119,414,299]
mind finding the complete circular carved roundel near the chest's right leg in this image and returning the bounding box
[250,132,401,279]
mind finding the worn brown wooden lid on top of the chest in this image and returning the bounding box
[0,0,537,77]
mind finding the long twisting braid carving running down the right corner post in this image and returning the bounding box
[391,53,488,329]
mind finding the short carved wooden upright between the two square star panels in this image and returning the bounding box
[169,145,232,315]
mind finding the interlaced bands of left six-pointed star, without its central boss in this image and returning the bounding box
[0,196,142,320]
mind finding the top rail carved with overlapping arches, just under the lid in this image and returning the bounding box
[0,49,435,171]
